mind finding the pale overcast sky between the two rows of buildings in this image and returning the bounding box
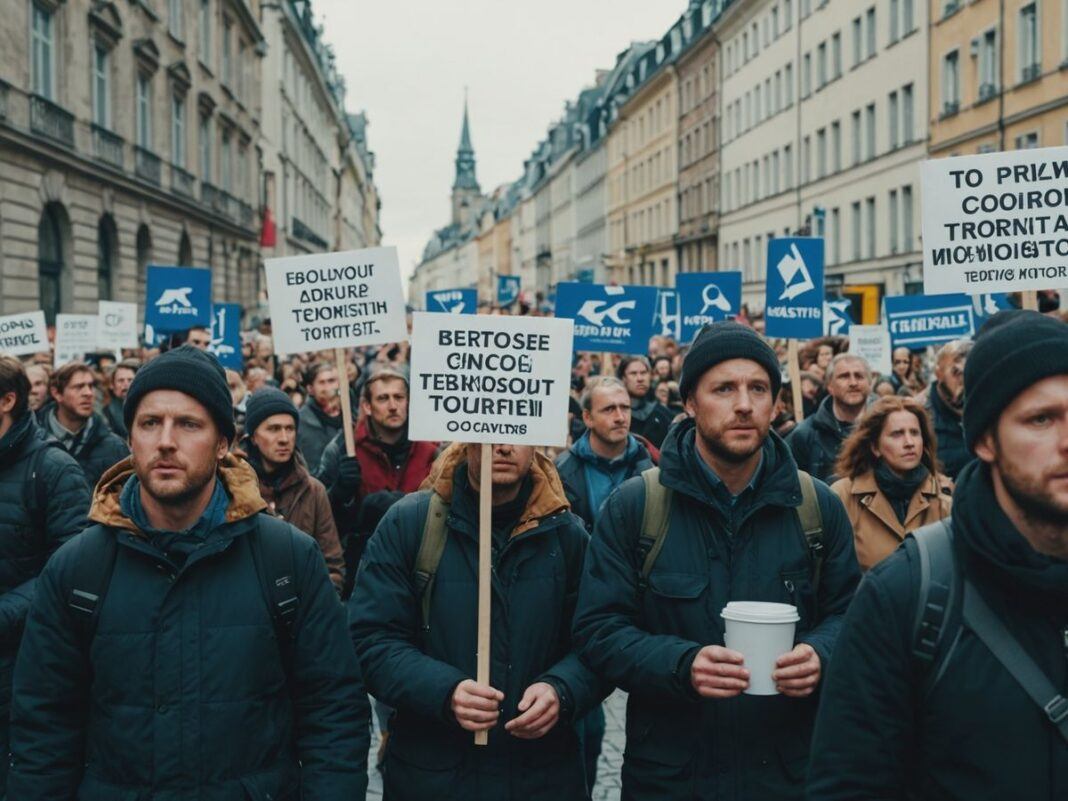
[312,0,687,286]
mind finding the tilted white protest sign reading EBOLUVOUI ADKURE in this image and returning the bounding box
[264,248,408,354]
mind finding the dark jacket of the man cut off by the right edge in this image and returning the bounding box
[808,461,1068,801]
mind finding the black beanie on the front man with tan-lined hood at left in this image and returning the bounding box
[123,345,236,441]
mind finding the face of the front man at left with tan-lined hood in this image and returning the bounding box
[130,390,229,506]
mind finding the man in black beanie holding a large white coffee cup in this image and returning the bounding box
[575,323,860,801]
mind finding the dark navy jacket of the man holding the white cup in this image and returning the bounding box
[575,420,860,801]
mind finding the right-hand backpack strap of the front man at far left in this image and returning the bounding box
[249,514,300,676]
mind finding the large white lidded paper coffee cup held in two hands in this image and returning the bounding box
[721,601,801,695]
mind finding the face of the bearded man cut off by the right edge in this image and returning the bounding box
[975,376,1068,529]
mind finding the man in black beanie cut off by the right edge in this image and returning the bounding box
[808,311,1068,801]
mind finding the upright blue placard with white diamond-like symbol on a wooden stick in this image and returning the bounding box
[764,237,823,340]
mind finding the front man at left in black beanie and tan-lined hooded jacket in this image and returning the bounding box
[7,345,370,801]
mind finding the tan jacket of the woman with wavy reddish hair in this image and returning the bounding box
[831,470,953,570]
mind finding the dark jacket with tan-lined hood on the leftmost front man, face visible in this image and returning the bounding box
[7,456,370,801]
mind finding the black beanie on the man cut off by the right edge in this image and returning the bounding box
[964,311,1068,451]
